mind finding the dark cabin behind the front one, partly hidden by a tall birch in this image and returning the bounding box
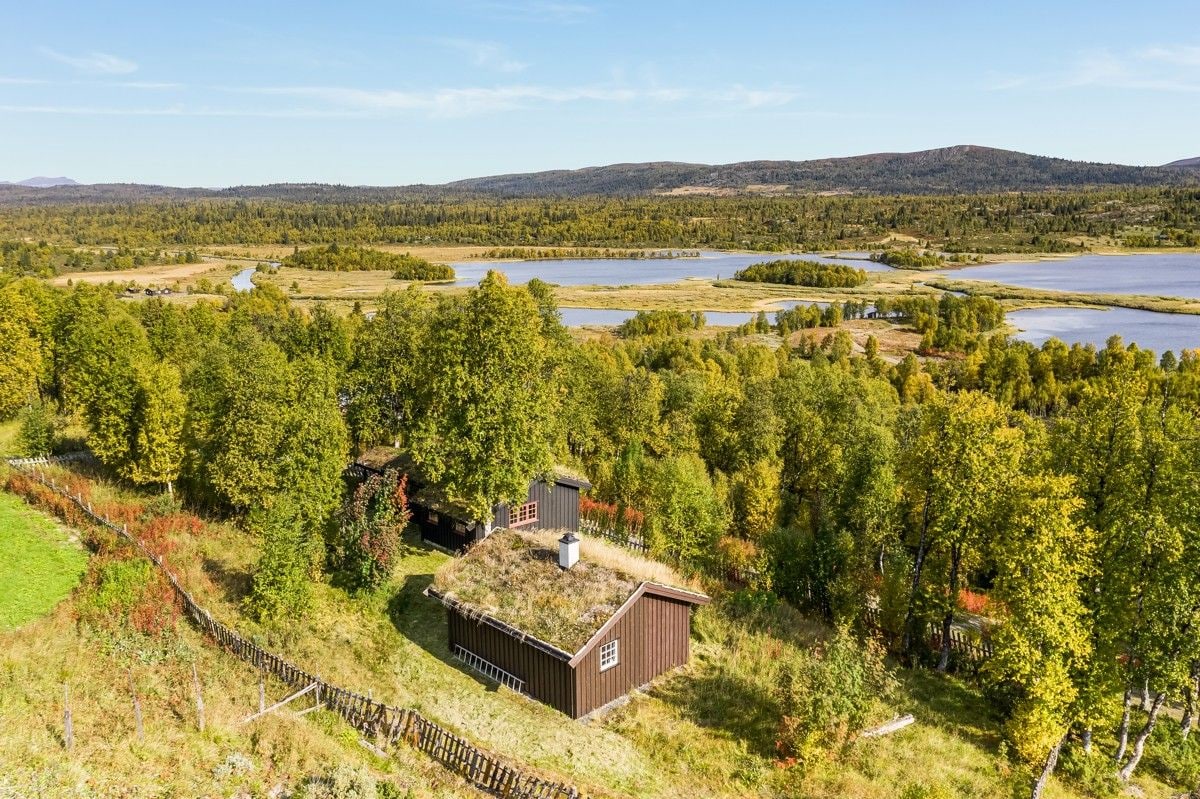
[354,446,592,552]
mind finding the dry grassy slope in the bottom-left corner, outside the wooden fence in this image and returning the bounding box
[0,475,481,799]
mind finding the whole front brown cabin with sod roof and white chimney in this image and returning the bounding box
[426,530,708,719]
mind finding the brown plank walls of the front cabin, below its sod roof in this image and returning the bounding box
[426,531,709,719]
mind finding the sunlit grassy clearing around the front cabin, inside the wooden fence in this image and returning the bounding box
[11,460,1170,799]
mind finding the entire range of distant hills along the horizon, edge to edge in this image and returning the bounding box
[0,145,1200,205]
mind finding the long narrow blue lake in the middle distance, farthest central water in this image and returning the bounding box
[451,252,892,286]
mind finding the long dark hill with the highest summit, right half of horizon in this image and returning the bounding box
[450,145,1198,196]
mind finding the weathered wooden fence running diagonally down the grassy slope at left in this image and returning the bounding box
[8,452,581,799]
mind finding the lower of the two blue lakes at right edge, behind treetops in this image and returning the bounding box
[1006,308,1200,354]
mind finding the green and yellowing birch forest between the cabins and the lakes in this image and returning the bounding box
[0,272,1200,795]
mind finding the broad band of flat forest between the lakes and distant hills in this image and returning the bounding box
[0,188,1200,252]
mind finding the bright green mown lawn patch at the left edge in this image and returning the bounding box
[0,493,88,631]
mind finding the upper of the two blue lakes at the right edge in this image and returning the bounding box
[937,253,1200,299]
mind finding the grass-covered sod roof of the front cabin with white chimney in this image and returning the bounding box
[432,530,704,655]
